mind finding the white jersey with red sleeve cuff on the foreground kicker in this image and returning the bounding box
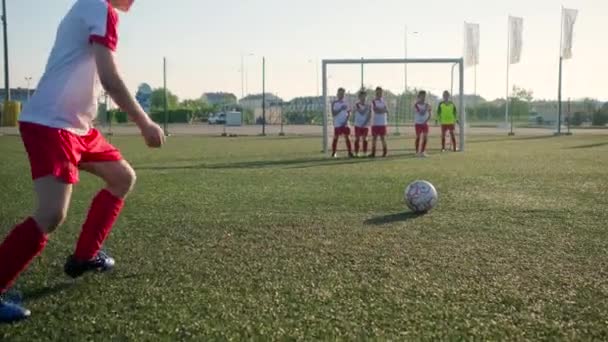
[19,0,118,135]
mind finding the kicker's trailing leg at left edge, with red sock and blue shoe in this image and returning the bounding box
[0,176,72,322]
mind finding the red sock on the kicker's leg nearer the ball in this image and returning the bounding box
[74,190,124,261]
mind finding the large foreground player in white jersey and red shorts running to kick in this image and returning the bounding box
[0,0,164,322]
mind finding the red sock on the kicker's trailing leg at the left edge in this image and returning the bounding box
[0,217,48,294]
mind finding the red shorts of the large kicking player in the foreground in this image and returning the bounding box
[19,122,123,184]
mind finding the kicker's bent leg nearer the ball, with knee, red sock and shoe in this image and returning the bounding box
[65,160,136,278]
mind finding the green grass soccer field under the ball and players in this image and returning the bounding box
[0,135,608,341]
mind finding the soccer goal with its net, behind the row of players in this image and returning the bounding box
[322,58,467,153]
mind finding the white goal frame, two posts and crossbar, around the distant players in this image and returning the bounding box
[322,58,466,154]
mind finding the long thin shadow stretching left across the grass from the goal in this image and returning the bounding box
[135,155,414,171]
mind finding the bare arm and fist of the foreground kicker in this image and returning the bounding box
[93,43,165,147]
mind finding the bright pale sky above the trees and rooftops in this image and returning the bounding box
[7,0,608,100]
